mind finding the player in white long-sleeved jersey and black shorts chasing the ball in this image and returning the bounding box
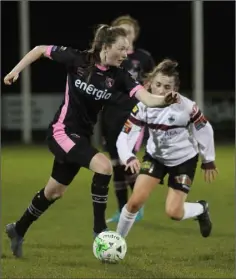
[117,59,217,237]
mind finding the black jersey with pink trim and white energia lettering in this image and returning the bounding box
[46,46,141,136]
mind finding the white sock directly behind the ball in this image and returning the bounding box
[116,205,138,237]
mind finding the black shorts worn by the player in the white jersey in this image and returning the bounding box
[140,153,198,193]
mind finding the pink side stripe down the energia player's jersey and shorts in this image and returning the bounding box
[52,80,75,153]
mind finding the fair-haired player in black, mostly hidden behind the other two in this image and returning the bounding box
[102,15,155,223]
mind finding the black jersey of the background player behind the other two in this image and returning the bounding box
[102,49,154,136]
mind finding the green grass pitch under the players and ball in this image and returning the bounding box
[1,146,235,278]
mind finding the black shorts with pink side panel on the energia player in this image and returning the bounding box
[47,133,98,185]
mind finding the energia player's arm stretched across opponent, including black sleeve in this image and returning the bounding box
[120,71,179,107]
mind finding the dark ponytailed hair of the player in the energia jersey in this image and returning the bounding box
[87,24,127,80]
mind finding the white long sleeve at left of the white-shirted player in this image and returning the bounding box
[116,102,146,164]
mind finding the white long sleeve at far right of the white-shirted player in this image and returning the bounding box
[190,103,215,164]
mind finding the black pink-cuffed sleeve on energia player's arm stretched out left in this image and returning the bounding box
[45,46,78,66]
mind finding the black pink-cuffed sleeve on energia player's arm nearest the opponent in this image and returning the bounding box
[119,70,143,97]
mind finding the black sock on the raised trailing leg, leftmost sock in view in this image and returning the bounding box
[15,188,55,237]
